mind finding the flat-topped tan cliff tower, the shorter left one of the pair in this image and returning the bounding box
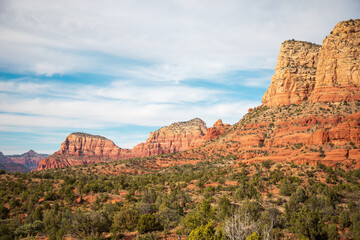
[262,41,321,106]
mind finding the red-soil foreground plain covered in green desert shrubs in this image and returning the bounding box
[0,157,360,240]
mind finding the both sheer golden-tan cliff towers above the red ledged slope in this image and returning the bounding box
[262,19,360,106]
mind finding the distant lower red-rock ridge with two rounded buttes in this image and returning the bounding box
[38,118,230,170]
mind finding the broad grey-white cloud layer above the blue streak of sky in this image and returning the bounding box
[0,0,360,81]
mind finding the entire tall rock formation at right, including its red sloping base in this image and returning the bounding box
[177,19,360,165]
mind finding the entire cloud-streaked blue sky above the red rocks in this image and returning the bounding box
[0,0,360,154]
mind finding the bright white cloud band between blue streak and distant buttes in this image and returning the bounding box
[0,78,258,131]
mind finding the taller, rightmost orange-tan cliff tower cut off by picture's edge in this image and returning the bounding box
[310,19,360,102]
